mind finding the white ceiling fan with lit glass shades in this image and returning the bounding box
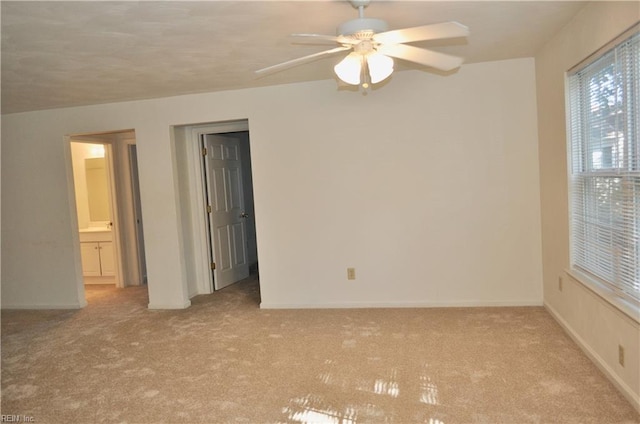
[256,0,469,89]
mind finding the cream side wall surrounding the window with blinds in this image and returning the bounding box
[536,2,640,410]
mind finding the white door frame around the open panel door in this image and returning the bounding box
[183,119,249,294]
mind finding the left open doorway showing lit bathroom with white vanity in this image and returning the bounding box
[69,130,146,294]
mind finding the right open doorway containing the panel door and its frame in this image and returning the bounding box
[174,120,258,297]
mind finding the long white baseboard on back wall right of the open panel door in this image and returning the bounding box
[260,300,543,309]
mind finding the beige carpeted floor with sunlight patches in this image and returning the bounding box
[1,279,640,424]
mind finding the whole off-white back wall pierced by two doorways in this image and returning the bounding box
[2,59,542,308]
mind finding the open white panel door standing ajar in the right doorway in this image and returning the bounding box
[204,134,249,290]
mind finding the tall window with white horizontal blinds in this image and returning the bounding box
[567,27,640,304]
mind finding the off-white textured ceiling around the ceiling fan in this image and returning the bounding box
[0,1,584,113]
